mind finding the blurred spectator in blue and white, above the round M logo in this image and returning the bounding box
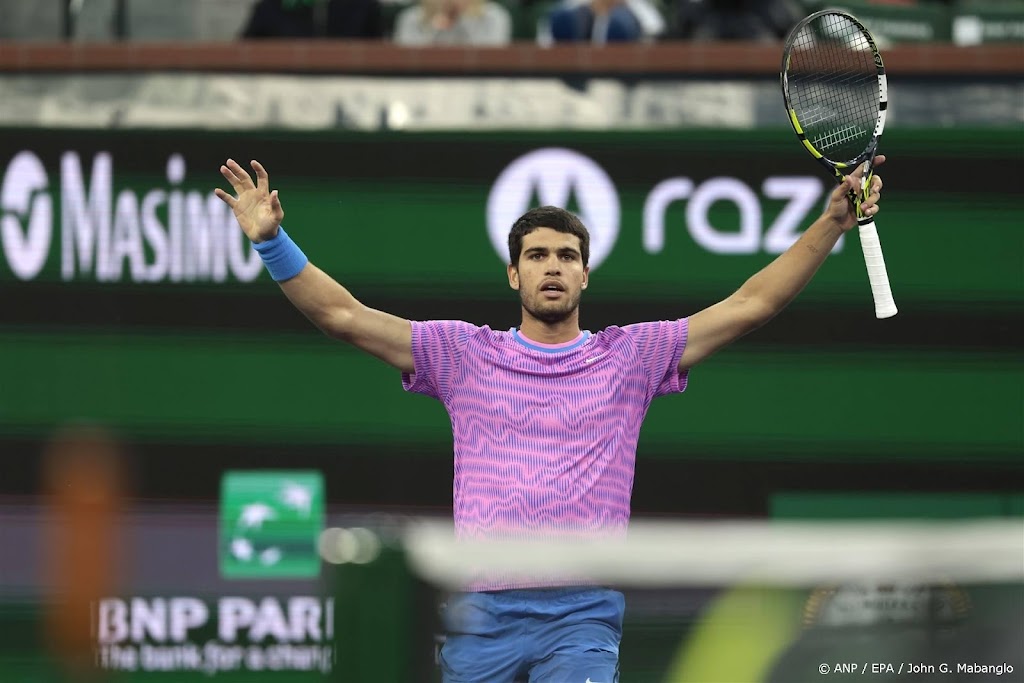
[539,0,665,45]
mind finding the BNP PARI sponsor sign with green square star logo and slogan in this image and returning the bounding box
[90,470,327,680]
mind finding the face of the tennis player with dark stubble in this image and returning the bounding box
[508,227,590,323]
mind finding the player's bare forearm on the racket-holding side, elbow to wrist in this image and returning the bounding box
[738,216,843,321]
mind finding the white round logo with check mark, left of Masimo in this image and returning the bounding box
[0,152,53,280]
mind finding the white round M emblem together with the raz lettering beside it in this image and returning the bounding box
[487,148,843,268]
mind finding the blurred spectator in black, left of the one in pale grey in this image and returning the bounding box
[242,0,384,38]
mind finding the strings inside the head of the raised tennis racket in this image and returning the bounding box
[786,14,880,162]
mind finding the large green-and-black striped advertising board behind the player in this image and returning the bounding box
[0,129,1024,461]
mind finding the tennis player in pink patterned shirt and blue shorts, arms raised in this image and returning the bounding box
[216,156,885,683]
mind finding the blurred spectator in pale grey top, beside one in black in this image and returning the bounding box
[394,0,512,46]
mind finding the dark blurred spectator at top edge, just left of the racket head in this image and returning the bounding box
[673,0,804,40]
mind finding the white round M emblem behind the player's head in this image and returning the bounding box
[487,147,620,270]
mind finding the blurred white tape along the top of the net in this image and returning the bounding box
[403,519,1024,589]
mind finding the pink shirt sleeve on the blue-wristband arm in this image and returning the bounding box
[401,321,479,401]
